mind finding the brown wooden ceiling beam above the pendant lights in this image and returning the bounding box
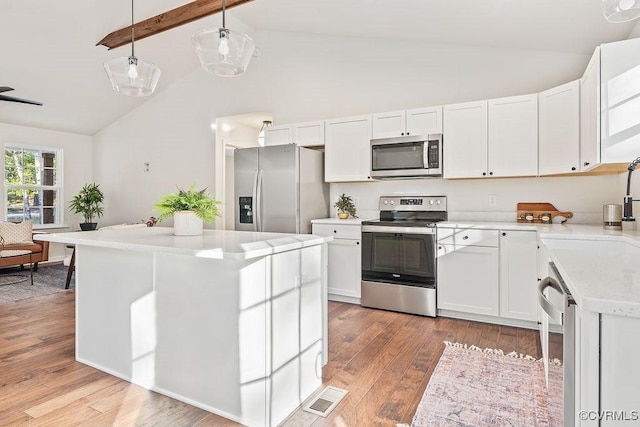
[96,0,252,50]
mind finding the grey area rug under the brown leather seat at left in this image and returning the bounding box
[0,264,74,304]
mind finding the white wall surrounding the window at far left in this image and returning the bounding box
[0,123,93,259]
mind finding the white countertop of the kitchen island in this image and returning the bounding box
[38,227,332,260]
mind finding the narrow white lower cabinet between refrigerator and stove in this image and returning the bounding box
[312,224,362,303]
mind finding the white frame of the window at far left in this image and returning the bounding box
[1,142,65,229]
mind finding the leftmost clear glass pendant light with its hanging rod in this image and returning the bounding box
[104,0,160,96]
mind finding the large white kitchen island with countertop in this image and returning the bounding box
[39,227,330,426]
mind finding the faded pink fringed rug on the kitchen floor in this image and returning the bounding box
[412,342,563,427]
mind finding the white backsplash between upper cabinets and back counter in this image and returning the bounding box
[331,174,628,224]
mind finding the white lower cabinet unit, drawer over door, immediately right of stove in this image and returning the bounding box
[437,229,499,316]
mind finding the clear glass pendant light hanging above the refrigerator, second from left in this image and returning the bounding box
[191,0,255,77]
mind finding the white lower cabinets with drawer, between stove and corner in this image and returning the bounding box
[437,227,538,325]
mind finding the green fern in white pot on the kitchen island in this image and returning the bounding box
[154,185,220,236]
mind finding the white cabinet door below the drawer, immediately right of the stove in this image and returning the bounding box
[437,244,499,316]
